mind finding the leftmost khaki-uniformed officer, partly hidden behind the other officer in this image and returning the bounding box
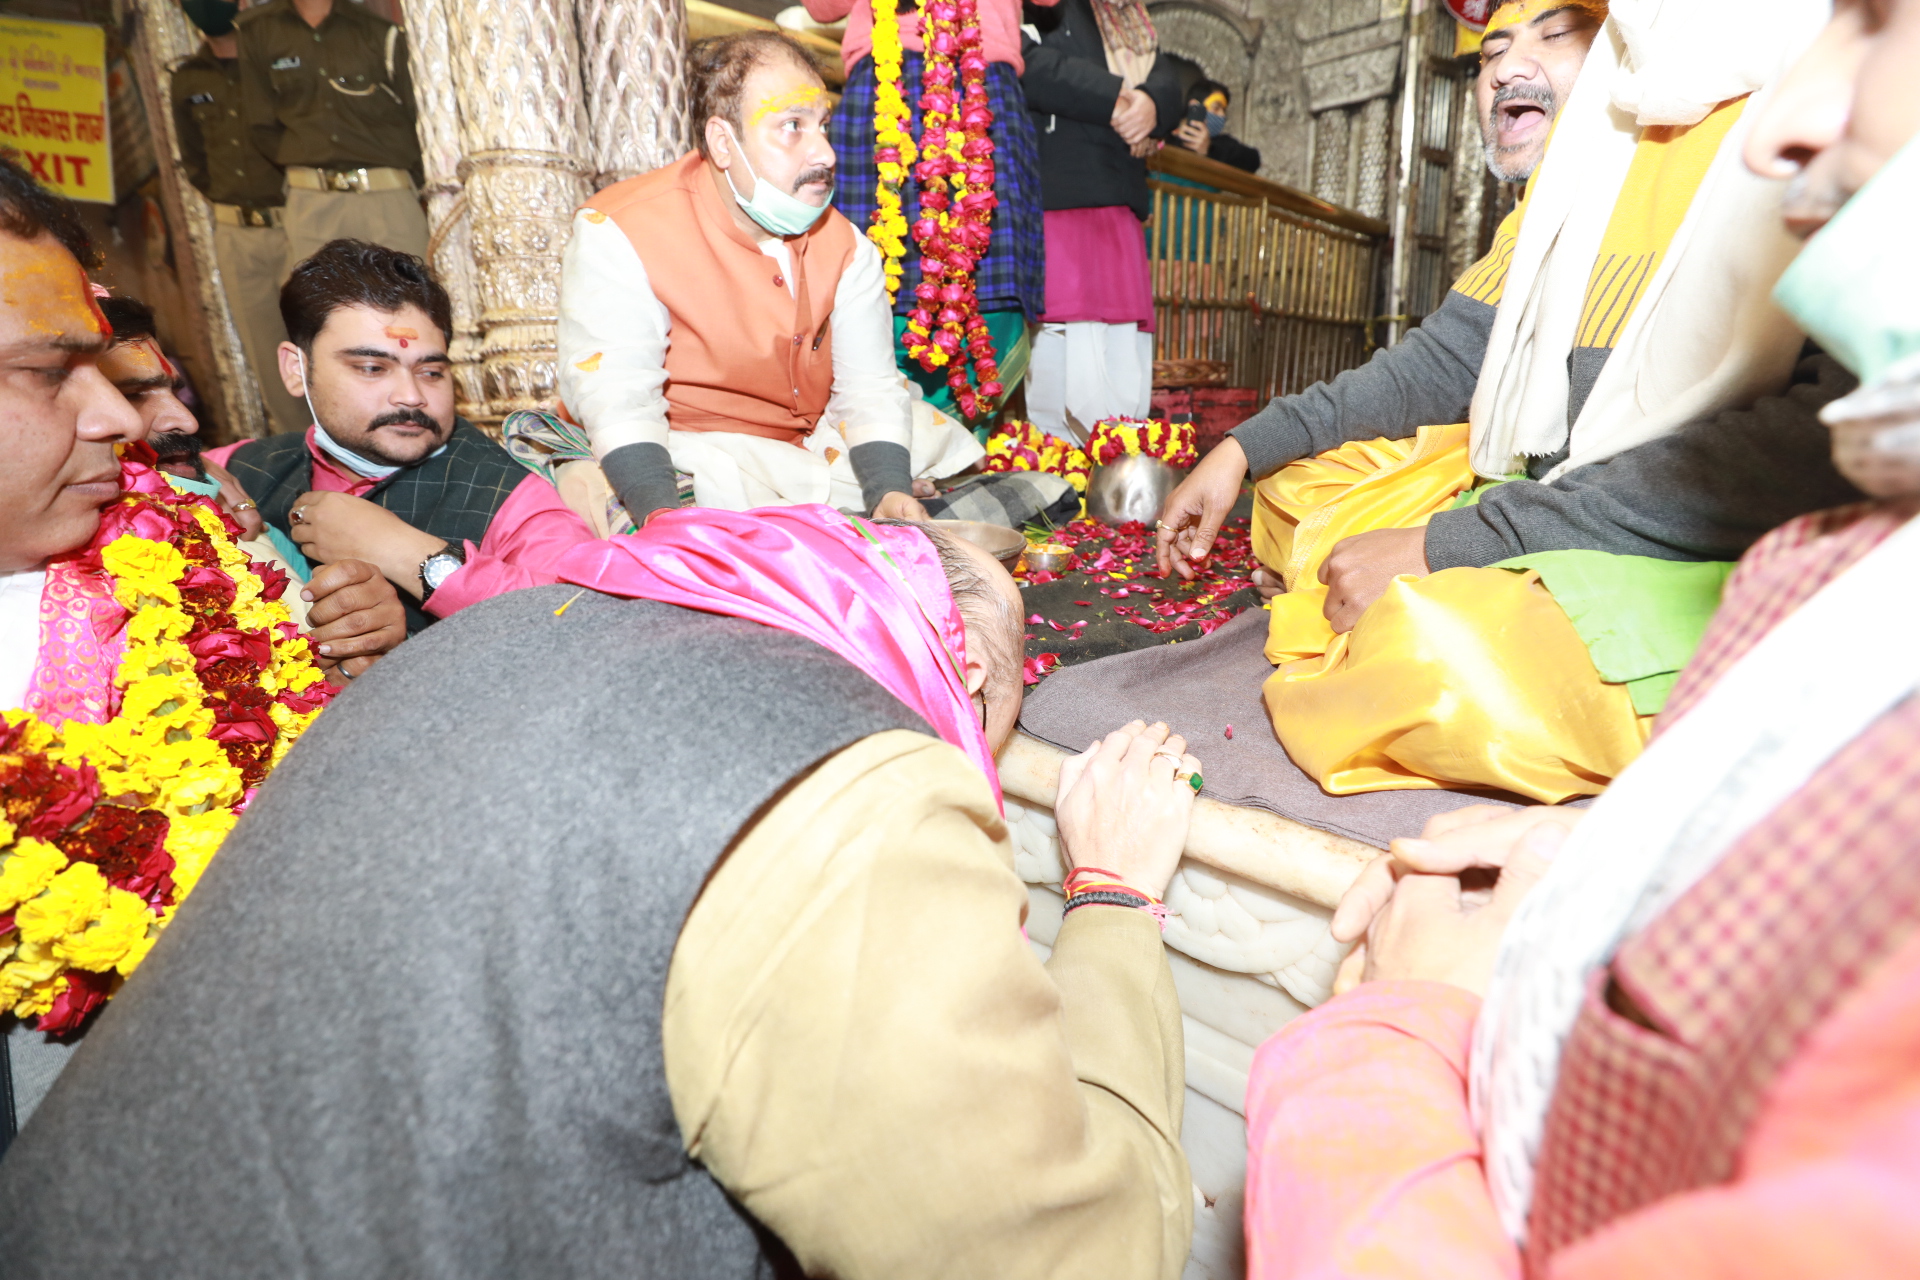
[173,0,309,432]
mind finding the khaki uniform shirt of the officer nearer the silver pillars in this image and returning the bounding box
[236,0,420,180]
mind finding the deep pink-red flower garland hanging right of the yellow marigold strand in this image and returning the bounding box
[894,0,1004,418]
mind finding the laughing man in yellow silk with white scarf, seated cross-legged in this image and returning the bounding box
[1160,0,1859,804]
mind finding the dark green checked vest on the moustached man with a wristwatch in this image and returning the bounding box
[227,418,526,635]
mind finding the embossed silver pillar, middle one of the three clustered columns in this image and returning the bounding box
[447,0,593,422]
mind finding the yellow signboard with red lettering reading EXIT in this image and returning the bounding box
[0,17,113,205]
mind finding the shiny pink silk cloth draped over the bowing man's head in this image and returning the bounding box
[557,505,1002,802]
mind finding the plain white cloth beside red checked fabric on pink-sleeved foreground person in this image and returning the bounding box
[1471,506,1920,1242]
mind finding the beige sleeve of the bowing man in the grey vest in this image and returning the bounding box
[660,731,1194,1280]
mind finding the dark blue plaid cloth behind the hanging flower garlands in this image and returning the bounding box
[828,50,1046,320]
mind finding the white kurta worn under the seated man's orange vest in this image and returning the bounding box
[559,211,985,510]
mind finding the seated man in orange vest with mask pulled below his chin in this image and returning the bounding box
[559,31,981,524]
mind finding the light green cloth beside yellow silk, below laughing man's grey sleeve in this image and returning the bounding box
[1490,551,1734,716]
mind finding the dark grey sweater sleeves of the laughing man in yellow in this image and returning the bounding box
[1233,292,1860,572]
